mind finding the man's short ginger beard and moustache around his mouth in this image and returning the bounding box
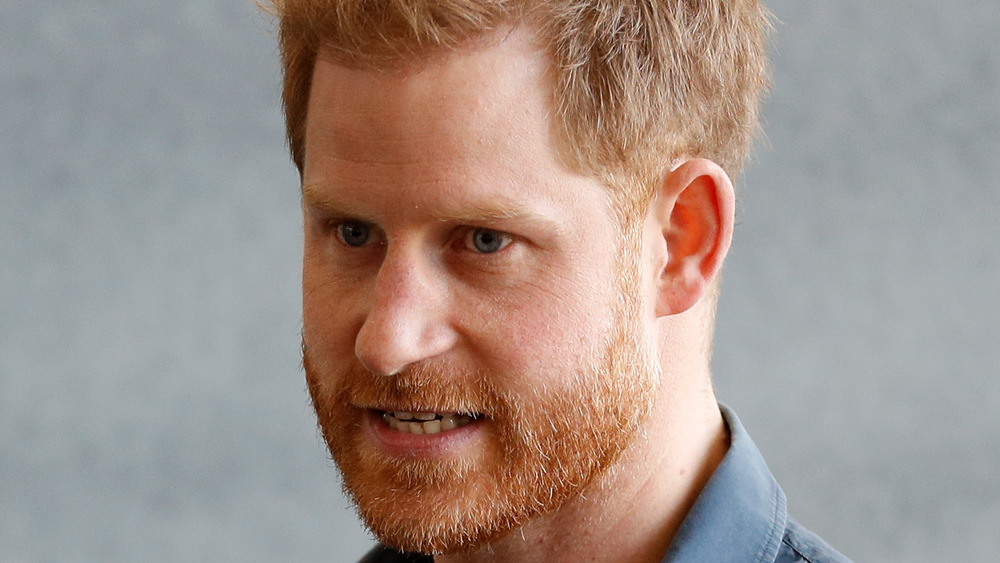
[303,298,659,553]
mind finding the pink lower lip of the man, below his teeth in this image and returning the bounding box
[364,409,488,458]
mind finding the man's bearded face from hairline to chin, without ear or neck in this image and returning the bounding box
[303,28,658,552]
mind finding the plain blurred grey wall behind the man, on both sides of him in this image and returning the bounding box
[0,0,1000,562]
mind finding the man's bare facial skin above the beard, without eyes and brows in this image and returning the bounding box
[303,37,618,388]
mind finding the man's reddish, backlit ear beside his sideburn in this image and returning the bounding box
[647,158,735,317]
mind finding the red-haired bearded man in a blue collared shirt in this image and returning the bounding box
[275,0,845,562]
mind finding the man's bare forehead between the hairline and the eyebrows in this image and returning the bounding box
[303,30,608,220]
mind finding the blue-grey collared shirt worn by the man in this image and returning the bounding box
[360,405,850,563]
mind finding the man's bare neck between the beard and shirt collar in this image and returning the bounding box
[435,326,729,563]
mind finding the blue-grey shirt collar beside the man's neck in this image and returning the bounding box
[663,405,788,563]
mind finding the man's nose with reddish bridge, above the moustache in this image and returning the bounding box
[354,249,456,375]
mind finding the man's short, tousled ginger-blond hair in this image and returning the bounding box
[272,0,770,203]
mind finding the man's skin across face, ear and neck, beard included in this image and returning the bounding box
[302,26,733,563]
